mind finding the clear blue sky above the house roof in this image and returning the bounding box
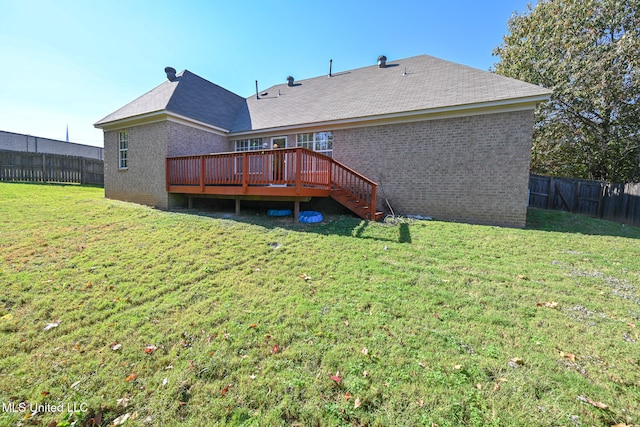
[0,0,529,146]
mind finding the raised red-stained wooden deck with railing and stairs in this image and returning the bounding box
[166,148,379,220]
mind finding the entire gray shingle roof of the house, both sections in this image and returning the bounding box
[96,55,550,132]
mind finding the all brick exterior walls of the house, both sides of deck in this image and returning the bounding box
[105,110,534,227]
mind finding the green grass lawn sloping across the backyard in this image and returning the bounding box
[0,183,640,427]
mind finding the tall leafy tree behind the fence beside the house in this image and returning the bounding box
[493,0,640,182]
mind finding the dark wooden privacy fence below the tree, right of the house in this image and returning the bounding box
[529,175,640,225]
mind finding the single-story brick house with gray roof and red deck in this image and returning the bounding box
[95,55,550,227]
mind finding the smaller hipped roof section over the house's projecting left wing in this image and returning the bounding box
[96,70,245,130]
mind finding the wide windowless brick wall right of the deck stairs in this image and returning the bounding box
[334,110,533,227]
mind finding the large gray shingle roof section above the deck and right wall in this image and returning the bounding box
[233,55,550,132]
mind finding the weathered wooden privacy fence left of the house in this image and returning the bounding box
[0,151,104,185]
